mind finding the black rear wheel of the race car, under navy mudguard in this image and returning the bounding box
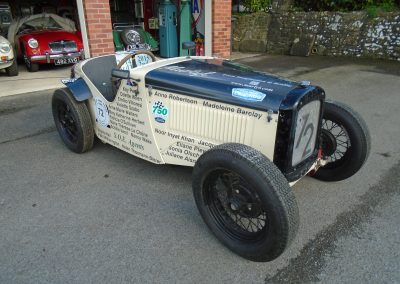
[52,88,94,153]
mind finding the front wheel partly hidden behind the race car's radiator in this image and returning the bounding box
[314,101,371,181]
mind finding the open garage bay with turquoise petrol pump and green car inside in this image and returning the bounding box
[110,0,211,57]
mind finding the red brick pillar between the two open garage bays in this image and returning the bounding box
[83,0,114,56]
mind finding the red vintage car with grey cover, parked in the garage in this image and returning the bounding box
[8,13,84,72]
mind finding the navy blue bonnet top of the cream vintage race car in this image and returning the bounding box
[145,59,301,111]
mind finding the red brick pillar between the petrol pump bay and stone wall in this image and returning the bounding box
[212,0,232,58]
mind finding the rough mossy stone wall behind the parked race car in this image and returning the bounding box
[233,12,400,60]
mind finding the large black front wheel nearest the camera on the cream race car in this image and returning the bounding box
[193,143,299,262]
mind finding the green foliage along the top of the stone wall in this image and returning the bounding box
[294,0,400,12]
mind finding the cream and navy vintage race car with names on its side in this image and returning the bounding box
[52,44,370,261]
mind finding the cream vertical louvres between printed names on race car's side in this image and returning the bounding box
[169,101,250,144]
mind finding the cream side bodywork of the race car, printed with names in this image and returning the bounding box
[77,57,278,166]
